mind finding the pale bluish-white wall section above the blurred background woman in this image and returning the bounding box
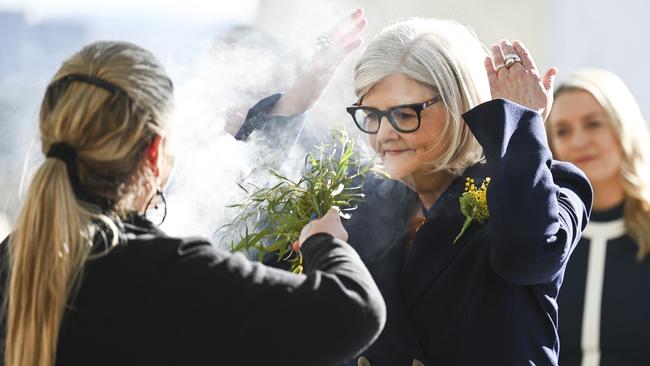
[550,0,650,117]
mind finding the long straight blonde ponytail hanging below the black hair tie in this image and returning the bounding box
[5,159,93,366]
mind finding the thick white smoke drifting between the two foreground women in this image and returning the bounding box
[156,2,364,241]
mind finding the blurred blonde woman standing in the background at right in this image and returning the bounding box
[547,69,650,366]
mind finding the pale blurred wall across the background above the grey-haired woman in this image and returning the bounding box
[257,0,650,120]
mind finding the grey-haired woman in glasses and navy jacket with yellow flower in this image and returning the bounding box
[346,19,591,366]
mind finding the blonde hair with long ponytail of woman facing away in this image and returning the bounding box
[3,42,173,366]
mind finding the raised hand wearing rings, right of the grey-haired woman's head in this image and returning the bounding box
[485,40,557,119]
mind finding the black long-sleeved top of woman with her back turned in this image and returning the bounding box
[1,219,385,366]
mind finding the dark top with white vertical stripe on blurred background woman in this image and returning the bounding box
[558,204,650,366]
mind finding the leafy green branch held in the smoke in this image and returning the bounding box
[224,130,375,273]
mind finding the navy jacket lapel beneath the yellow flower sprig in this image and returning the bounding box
[401,164,486,309]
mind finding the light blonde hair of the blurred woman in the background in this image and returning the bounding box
[546,68,650,260]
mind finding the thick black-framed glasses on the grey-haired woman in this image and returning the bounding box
[345,95,440,134]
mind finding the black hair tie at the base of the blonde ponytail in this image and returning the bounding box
[47,142,113,211]
